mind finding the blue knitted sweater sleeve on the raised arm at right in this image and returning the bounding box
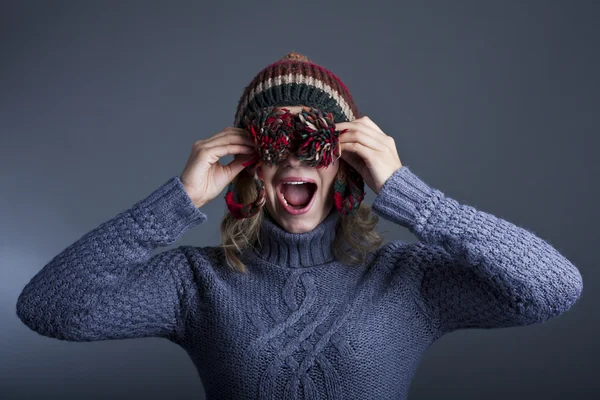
[372,166,583,335]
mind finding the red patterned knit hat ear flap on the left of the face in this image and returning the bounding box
[225,167,266,219]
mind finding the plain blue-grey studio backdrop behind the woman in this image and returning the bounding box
[0,0,600,399]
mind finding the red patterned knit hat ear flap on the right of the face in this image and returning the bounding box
[334,159,365,215]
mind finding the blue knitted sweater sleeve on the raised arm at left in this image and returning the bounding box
[16,176,206,342]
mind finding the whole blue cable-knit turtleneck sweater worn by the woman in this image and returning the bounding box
[17,166,583,400]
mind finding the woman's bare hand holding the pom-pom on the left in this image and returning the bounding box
[179,127,256,207]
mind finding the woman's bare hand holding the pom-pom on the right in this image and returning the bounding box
[335,116,402,194]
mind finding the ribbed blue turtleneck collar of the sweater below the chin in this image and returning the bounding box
[250,208,341,268]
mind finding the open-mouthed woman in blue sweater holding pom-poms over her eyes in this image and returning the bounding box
[17,53,583,399]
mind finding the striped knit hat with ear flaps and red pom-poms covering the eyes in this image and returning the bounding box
[225,52,364,219]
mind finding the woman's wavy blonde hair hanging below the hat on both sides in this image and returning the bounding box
[219,169,384,273]
